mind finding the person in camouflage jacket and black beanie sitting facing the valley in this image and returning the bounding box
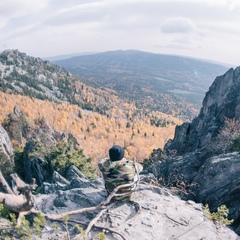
[98,145,143,201]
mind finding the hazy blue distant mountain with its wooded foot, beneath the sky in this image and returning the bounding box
[54,50,228,120]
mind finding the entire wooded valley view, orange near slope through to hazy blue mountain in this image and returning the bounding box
[0,50,231,163]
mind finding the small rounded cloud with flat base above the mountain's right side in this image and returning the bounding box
[160,17,197,33]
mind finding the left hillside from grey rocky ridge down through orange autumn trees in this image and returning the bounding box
[0,50,181,161]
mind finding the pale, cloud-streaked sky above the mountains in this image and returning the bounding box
[0,0,240,67]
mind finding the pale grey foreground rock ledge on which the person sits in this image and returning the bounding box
[36,168,240,240]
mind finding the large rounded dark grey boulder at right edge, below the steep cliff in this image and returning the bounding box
[192,152,240,220]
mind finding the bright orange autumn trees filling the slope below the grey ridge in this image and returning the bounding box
[0,92,178,163]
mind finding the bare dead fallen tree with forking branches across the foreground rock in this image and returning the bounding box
[0,171,141,240]
